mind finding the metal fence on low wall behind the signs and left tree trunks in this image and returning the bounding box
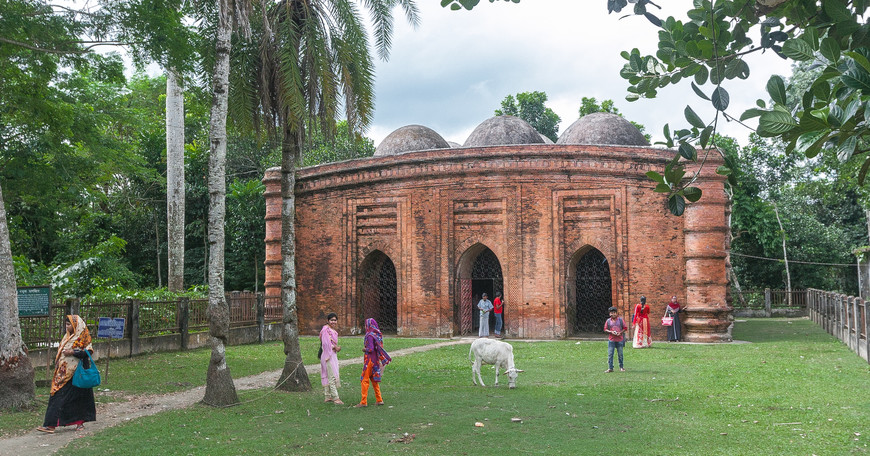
[19,292,282,350]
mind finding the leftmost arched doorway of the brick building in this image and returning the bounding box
[357,250,398,334]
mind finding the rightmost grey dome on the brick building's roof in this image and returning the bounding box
[556,112,649,146]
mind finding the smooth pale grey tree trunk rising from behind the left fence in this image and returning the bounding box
[166,68,185,291]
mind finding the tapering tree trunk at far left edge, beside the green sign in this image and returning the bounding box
[0,182,34,410]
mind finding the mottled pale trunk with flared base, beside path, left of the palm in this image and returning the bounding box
[202,0,239,406]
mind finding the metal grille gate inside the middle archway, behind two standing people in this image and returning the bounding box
[458,248,504,335]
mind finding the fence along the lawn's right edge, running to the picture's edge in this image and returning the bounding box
[807,288,870,362]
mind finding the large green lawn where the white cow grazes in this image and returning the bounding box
[52,319,870,456]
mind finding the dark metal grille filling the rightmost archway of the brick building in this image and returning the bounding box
[573,249,612,335]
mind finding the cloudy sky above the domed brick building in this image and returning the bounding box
[367,0,791,145]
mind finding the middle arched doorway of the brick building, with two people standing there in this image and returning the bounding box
[454,244,507,335]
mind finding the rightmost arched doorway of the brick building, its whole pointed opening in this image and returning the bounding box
[566,246,613,336]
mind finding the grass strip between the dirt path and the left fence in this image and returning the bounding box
[0,337,439,436]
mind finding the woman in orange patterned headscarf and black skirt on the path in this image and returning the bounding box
[36,315,97,434]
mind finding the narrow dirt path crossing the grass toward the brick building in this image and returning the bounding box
[0,339,474,456]
